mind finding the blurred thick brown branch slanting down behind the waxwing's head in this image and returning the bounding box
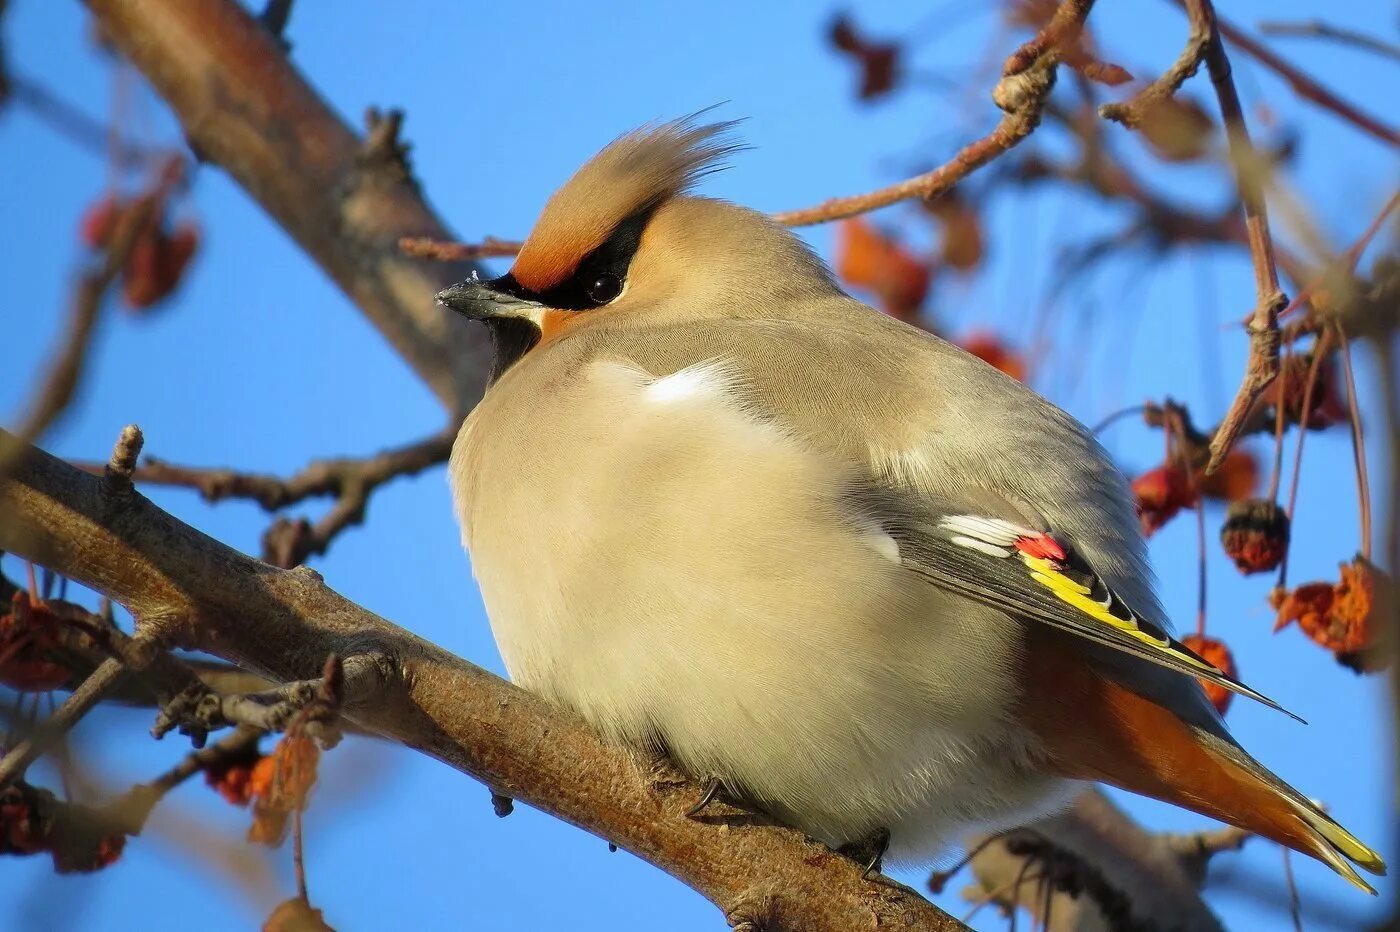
[87,0,490,413]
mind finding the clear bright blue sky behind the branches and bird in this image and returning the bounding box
[0,0,1400,932]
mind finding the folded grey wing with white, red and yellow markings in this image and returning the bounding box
[890,515,1302,721]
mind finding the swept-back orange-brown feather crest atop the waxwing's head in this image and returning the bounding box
[511,115,742,291]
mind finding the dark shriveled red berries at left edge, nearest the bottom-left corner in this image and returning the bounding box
[0,781,126,873]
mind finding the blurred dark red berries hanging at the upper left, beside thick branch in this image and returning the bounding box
[80,184,199,309]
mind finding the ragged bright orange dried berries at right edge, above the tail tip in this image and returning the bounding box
[1270,557,1392,672]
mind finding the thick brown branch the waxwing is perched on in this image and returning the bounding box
[0,432,962,932]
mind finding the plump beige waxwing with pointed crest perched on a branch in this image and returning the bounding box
[437,115,1385,893]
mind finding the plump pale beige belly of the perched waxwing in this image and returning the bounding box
[458,358,1053,854]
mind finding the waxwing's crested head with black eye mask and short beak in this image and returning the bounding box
[437,118,836,374]
